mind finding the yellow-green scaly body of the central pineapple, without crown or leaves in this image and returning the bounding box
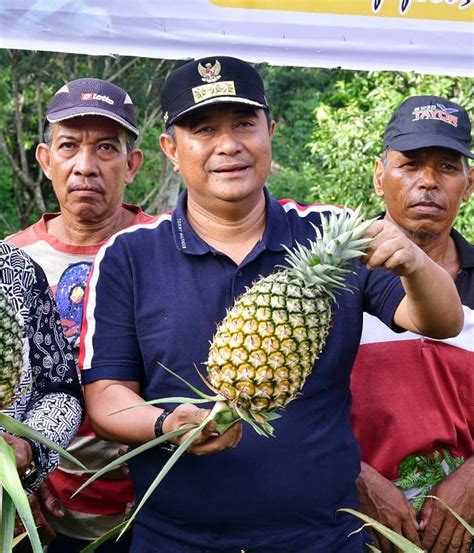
[207,270,331,416]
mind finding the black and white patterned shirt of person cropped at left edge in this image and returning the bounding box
[0,241,83,491]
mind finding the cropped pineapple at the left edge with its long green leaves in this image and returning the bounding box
[0,294,85,553]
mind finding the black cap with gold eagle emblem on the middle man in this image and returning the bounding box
[161,56,269,128]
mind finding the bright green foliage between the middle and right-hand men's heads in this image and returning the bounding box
[264,69,474,241]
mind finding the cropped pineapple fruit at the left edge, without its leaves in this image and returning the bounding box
[0,294,23,409]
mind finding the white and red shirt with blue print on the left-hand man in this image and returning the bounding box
[8,204,155,540]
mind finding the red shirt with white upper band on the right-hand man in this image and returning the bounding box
[351,229,474,480]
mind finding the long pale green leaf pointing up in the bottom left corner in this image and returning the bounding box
[0,437,43,553]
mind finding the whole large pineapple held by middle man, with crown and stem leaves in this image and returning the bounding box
[76,209,373,531]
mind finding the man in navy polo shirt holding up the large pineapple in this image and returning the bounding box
[81,61,462,553]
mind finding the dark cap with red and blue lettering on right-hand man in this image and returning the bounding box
[384,96,474,158]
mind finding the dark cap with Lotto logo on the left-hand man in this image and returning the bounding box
[46,78,139,136]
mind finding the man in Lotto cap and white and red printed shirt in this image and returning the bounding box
[10,78,152,553]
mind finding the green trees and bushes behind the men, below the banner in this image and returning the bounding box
[0,50,474,241]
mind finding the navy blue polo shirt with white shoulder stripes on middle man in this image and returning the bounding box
[82,191,404,553]
